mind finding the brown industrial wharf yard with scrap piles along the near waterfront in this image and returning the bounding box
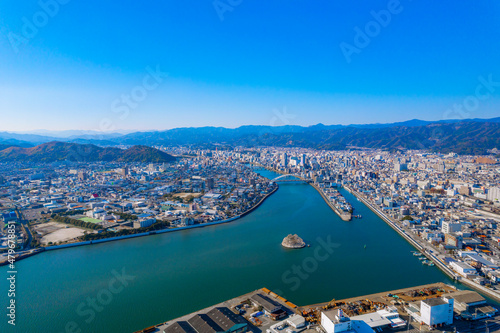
[137,283,500,333]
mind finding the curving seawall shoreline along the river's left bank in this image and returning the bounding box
[0,186,279,266]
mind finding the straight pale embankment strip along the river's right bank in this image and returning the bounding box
[345,187,500,302]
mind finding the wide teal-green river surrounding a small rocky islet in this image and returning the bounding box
[0,171,458,333]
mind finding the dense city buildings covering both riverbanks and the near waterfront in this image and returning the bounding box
[0,146,500,333]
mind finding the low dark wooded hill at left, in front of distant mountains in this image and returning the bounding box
[0,141,175,163]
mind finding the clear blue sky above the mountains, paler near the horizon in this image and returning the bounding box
[0,0,500,131]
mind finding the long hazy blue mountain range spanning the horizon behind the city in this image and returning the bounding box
[0,117,500,154]
